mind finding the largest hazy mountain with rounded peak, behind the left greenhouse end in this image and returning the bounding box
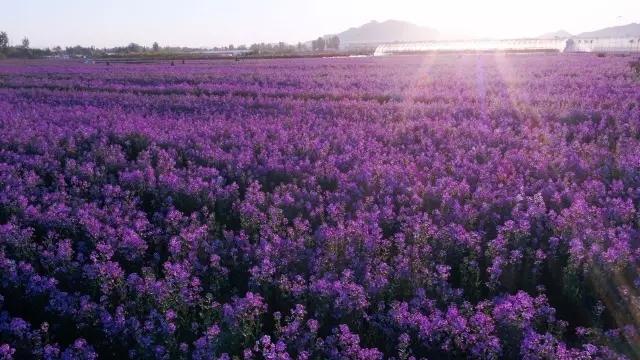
[336,20,440,46]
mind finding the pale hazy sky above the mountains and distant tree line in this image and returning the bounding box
[0,0,640,47]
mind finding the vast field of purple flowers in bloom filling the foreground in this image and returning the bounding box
[0,54,640,360]
